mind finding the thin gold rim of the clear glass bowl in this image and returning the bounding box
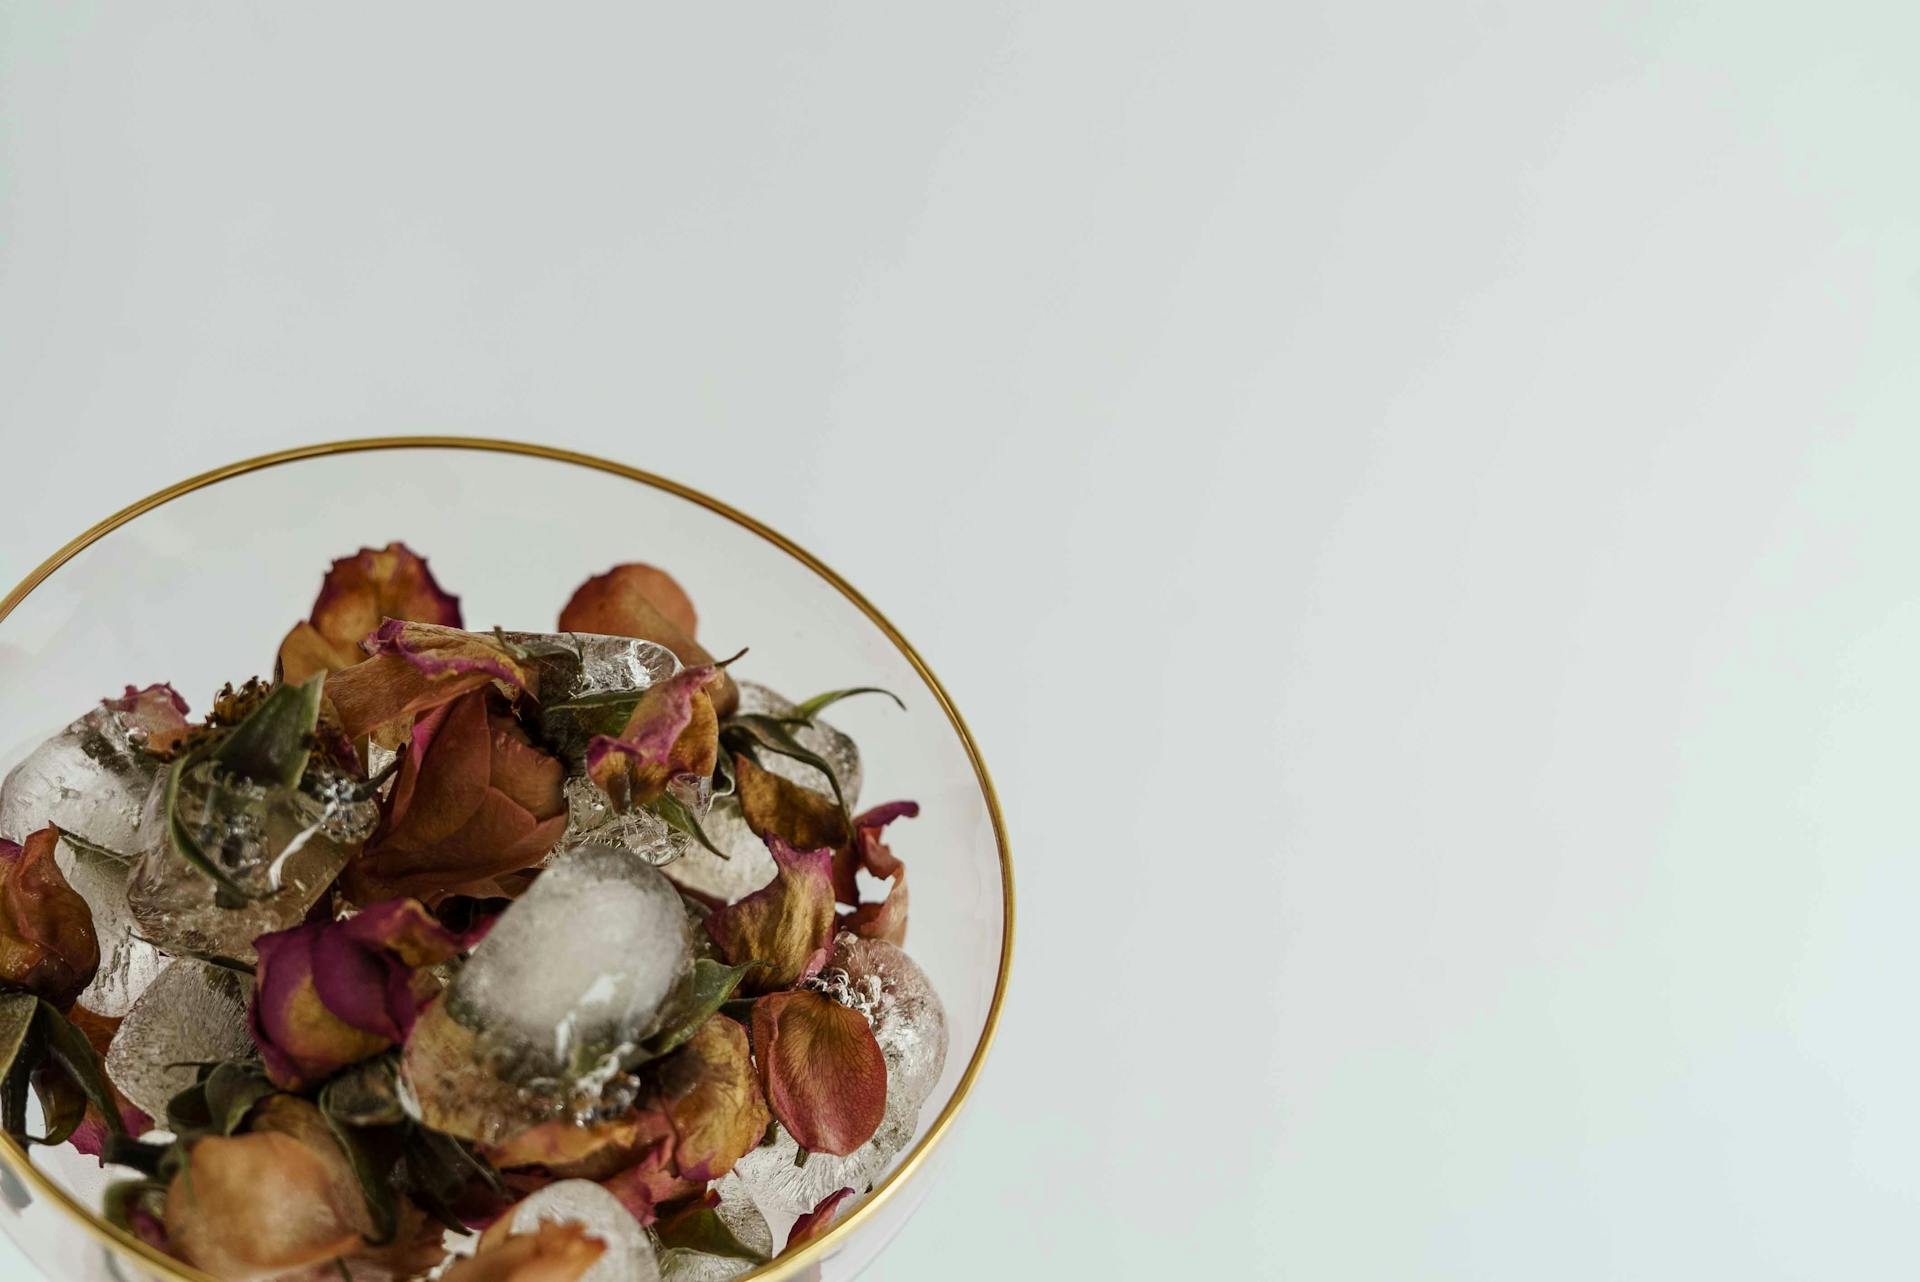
[0,436,1014,1282]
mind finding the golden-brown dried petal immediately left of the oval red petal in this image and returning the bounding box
[660,1015,770,1184]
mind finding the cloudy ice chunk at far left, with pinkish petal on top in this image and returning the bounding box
[0,704,161,858]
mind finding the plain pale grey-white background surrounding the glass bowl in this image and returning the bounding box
[0,0,1920,1282]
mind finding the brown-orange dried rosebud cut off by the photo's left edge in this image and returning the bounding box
[0,823,100,1009]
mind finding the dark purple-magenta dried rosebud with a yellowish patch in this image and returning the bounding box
[248,900,459,1090]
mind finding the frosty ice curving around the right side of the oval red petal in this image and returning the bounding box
[733,933,947,1215]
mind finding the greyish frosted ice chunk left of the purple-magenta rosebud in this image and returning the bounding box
[108,958,253,1123]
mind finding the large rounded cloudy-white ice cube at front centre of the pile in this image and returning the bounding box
[447,846,693,1113]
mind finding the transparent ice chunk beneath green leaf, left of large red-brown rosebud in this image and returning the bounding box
[127,762,376,962]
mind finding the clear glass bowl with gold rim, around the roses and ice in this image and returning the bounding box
[0,438,1012,1282]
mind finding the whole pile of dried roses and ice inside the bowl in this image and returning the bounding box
[0,543,945,1282]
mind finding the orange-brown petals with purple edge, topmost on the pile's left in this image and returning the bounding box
[280,543,461,685]
